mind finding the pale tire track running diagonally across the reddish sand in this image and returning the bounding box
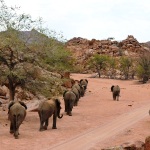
[49,105,149,150]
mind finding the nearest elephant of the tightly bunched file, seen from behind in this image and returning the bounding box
[63,90,76,116]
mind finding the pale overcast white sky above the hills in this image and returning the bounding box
[4,0,150,42]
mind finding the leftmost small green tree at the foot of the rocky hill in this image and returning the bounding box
[89,54,108,78]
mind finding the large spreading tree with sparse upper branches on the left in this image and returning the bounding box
[0,0,73,100]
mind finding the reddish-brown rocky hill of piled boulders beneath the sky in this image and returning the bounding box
[66,35,150,70]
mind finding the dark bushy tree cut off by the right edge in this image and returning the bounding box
[137,53,150,83]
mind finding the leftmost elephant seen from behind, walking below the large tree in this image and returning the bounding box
[8,101,27,139]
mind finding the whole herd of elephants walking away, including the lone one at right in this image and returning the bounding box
[8,79,120,139]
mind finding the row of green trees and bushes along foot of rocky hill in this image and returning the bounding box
[88,53,150,83]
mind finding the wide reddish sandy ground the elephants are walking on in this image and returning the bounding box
[0,74,150,150]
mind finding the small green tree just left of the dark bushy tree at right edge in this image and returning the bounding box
[120,56,133,80]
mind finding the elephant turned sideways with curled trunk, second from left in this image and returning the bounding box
[38,98,63,131]
